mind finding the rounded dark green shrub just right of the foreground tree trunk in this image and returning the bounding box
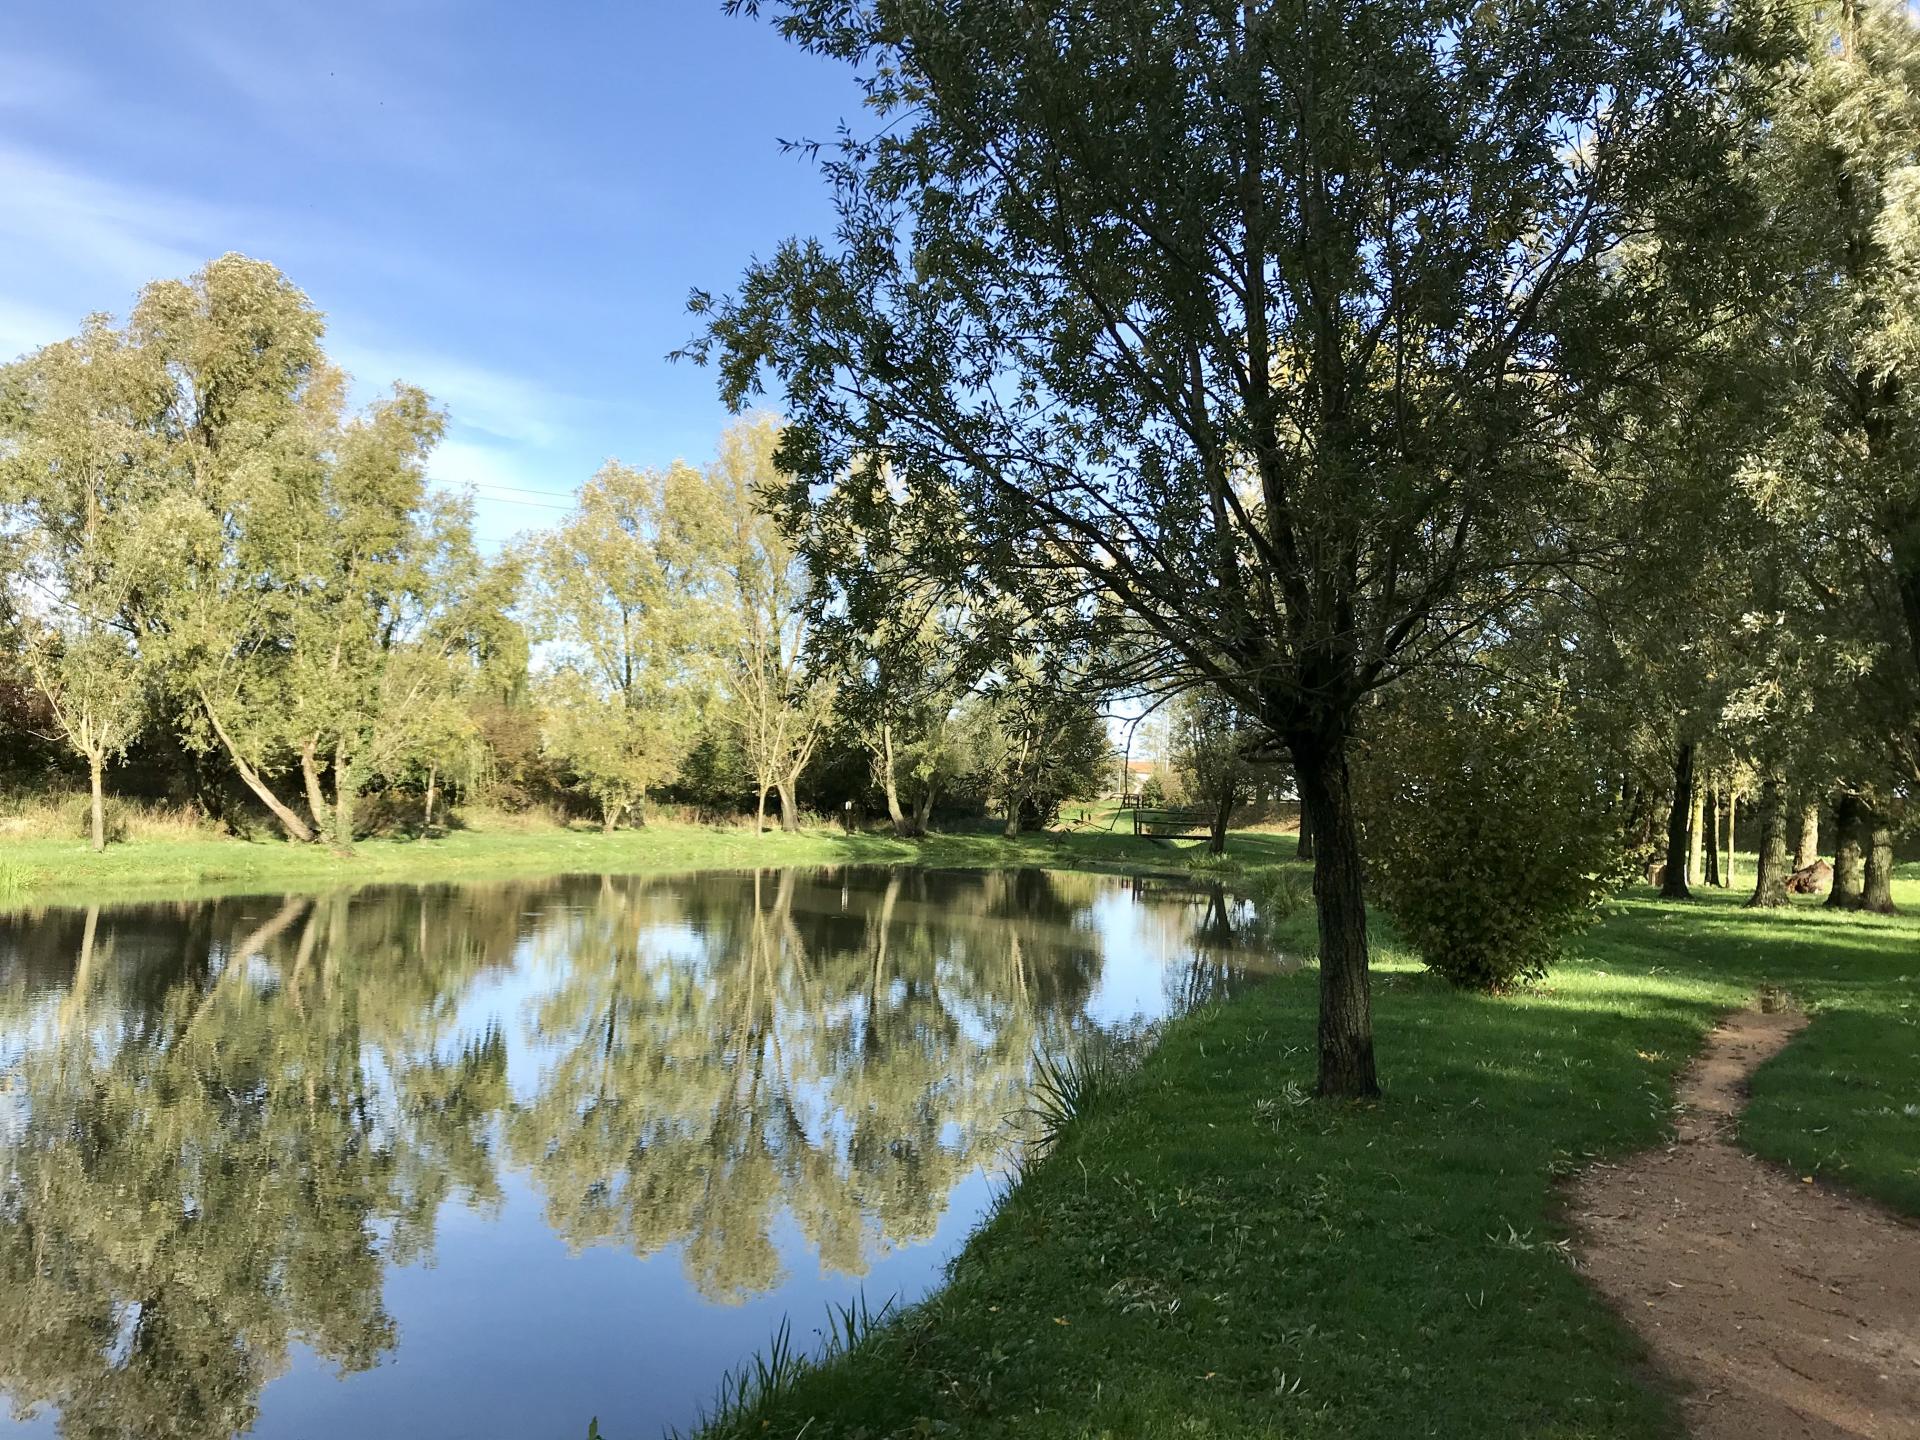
[1354,697,1632,989]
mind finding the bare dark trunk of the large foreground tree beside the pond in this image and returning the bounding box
[1288,732,1380,1098]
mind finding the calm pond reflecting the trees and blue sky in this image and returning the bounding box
[0,868,1256,1440]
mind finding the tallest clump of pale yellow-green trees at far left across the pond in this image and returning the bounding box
[0,255,511,843]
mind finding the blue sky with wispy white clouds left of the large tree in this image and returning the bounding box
[0,0,860,545]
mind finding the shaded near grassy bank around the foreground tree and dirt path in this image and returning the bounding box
[679,874,1920,1440]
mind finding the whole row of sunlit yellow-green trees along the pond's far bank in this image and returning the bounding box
[0,255,1108,849]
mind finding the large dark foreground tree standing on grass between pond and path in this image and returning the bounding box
[689,0,1758,1096]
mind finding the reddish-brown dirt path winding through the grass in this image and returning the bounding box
[1571,1010,1920,1440]
